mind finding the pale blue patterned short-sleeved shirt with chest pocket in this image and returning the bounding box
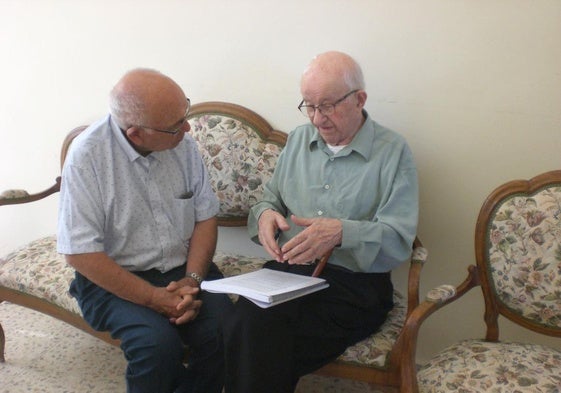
[57,115,219,272]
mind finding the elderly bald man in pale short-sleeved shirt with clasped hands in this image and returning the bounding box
[57,69,232,393]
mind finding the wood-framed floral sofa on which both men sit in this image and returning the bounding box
[0,102,426,391]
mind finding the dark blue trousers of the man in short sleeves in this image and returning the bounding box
[70,264,232,393]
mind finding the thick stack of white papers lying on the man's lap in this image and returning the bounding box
[201,268,329,308]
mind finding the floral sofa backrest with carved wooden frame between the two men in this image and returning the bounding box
[189,102,287,226]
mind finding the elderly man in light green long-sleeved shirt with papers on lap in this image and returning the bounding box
[225,52,418,393]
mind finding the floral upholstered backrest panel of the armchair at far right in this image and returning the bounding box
[488,185,561,328]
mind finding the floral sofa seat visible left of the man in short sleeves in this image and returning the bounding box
[0,236,82,315]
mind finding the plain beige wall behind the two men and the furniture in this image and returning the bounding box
[0,0,561,360]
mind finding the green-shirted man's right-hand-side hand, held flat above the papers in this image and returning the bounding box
[281,215,343,264]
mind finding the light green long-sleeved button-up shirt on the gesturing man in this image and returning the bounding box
[248,112,419,273]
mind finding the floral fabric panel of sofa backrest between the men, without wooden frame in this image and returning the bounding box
[189,114,282,218]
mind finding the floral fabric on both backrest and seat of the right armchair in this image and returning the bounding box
[417,184,561,393]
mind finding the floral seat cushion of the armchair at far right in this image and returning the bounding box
[417,340,561,393]
